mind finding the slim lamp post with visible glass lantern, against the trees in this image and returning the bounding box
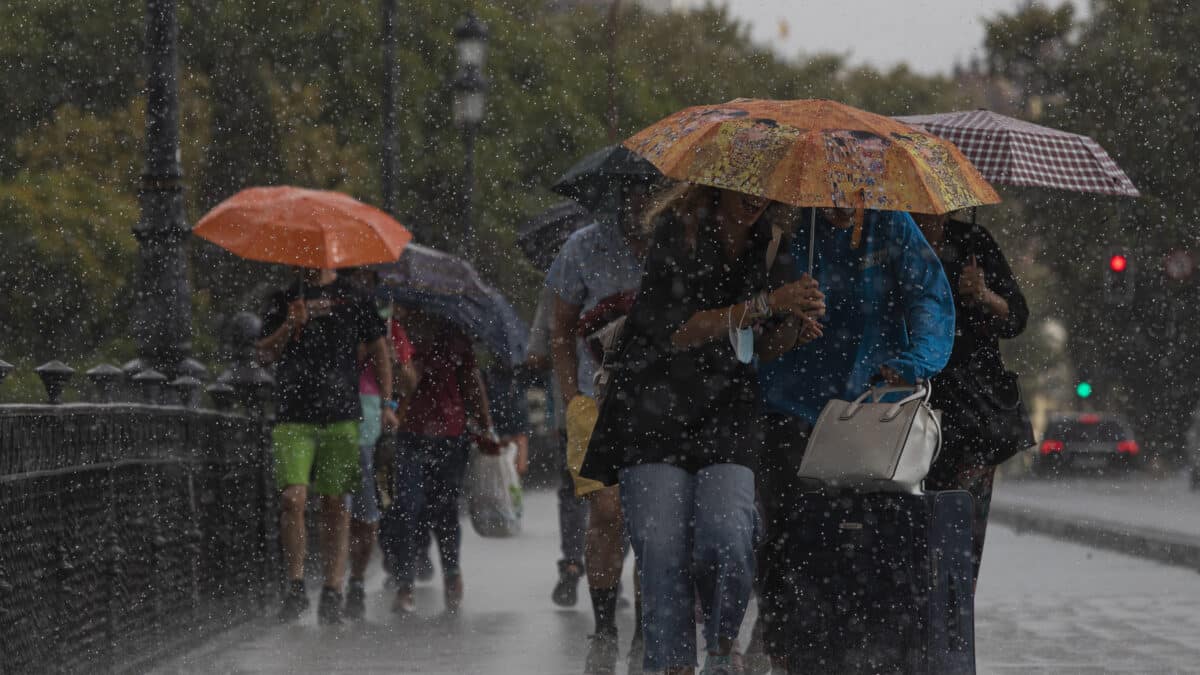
[454,13,487,259]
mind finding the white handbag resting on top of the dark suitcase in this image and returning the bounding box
[798,382,942,492]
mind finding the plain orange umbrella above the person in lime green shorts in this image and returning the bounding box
[192,186,413,269]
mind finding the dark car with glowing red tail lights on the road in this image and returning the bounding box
[1033,412,1141,476]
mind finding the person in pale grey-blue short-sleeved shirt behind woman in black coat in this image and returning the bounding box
[546,184,650,674]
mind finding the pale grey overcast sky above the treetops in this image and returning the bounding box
[695,0,1084,73]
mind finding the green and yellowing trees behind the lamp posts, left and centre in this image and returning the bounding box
[0,0,962,372]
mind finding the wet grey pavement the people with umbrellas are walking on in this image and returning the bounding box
[158,486,1200,675]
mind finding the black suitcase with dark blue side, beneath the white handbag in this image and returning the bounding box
[774,491,974,674]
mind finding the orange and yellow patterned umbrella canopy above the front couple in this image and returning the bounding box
[625,98,1000,214]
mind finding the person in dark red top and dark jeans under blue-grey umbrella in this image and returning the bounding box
[385,311,494,614]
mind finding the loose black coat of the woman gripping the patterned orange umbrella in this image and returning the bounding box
[582,214,770,485]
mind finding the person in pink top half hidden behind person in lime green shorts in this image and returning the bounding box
[346,268,418,620]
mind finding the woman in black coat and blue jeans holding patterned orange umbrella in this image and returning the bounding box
[582,184,823,675]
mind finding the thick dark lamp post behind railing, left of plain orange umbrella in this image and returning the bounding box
[132,0,192,376]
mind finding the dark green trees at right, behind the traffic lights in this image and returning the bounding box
[988,0,1200,447]
